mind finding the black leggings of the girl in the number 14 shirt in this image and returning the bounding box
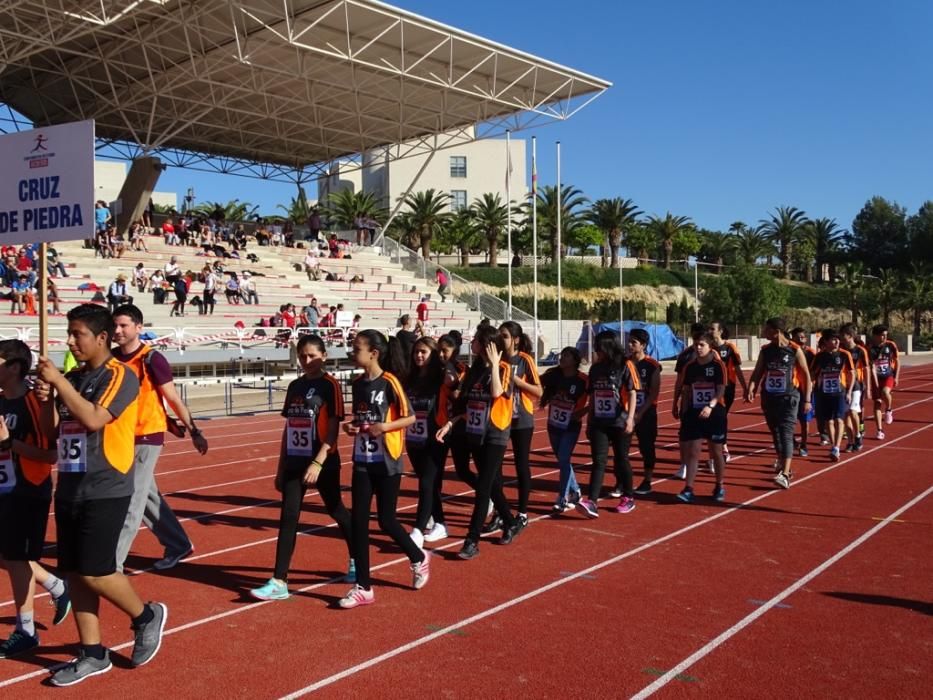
[351,464,424,589]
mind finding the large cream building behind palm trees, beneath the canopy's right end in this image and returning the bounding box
[318,139,531,211]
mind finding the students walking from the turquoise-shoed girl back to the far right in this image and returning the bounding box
[251,318,898,608]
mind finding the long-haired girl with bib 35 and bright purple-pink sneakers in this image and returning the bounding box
[577,331,641,518]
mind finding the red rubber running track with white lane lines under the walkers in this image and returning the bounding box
[0,365,933,699]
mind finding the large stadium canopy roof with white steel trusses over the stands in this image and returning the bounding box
[0,0,610,183]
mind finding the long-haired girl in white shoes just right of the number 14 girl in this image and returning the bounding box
[405,336,447,547]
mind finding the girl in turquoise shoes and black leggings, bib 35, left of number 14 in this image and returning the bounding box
[250,335,356,600]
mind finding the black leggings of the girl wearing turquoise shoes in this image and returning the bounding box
[273,469,353,581]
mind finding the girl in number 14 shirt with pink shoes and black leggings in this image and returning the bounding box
[340,330,431,608]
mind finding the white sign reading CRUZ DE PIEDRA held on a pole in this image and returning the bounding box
[0,120,94,245]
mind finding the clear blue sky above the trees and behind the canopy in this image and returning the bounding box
[158,0,933,230]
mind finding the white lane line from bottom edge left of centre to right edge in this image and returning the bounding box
[274,408,933,700]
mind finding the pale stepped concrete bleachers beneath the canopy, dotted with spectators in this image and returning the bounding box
[0,235,478,352]
